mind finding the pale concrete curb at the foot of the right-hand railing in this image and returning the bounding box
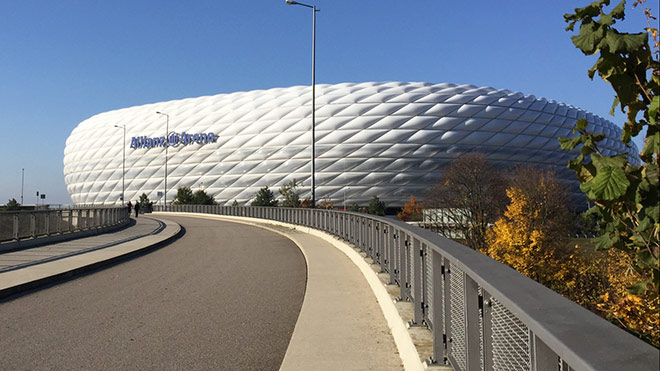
[158,212,426,371]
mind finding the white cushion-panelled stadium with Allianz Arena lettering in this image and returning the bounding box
[64,82,636,207]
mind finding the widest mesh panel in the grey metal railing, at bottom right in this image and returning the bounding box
[491,299,531,371]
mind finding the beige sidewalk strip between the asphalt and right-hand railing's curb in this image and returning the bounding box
[162,213,416,371]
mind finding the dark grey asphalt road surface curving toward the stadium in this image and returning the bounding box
[0,216,306,370]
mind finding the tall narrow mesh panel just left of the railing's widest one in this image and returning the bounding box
[449,264,467,371]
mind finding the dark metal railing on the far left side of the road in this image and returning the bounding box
[0,207,130,246]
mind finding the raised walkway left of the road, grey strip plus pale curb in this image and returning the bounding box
[0,217,181,301]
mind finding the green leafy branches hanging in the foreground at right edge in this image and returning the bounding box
[559,0,660,296]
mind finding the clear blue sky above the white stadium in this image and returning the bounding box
[0,0,658,204]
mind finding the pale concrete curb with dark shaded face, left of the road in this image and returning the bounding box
[0,219,183,302]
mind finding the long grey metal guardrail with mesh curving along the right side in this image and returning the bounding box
[155,205,660,371]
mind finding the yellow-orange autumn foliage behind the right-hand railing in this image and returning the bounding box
[482,185,660,346]
